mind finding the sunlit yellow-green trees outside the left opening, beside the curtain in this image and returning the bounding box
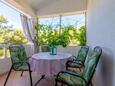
[0,15,28,44]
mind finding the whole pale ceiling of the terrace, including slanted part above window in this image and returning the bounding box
[5,0,87,15]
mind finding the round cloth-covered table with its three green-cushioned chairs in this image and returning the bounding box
[4,44,102,86]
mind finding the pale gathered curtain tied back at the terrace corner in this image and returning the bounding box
[20,14,38,53]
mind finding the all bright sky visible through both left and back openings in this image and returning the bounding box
[0,2,85,29]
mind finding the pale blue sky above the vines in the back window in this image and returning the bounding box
[39,14,85,28]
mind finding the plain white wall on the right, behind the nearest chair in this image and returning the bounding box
[87,0,115,86]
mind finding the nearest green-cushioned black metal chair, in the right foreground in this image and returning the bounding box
[55,46,102,86]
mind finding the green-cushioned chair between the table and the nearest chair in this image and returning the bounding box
[66,46,89,71]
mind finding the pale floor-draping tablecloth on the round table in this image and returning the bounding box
[30,52,72,76]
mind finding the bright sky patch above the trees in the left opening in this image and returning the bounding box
[0,2,22,29]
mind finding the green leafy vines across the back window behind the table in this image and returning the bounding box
[36,24,86,47]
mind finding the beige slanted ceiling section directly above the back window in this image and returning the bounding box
[37,0,87,16]
